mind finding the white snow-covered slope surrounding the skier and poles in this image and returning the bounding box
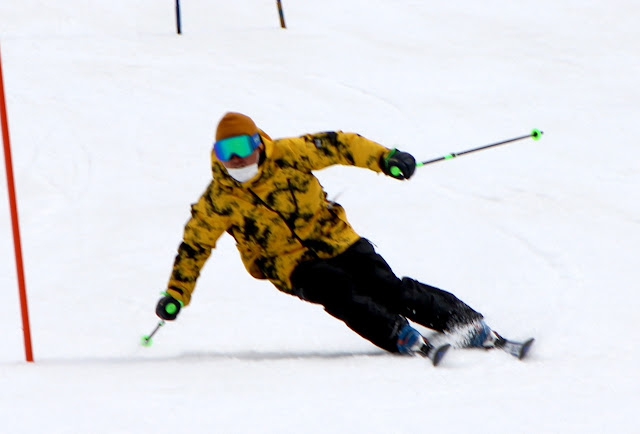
[0,0,640,434]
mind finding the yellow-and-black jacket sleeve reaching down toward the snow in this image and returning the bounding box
[167,189,227,306]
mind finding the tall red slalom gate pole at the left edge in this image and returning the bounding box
[0,43,33,362]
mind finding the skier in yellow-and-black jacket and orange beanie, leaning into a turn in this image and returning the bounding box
[156,112,510,364]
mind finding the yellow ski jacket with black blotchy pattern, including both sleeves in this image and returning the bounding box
[167,131,390,305]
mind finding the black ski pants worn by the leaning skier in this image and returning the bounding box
[291,238,482,352]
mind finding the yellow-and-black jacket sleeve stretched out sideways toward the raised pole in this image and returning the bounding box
[278,131,391,172]
